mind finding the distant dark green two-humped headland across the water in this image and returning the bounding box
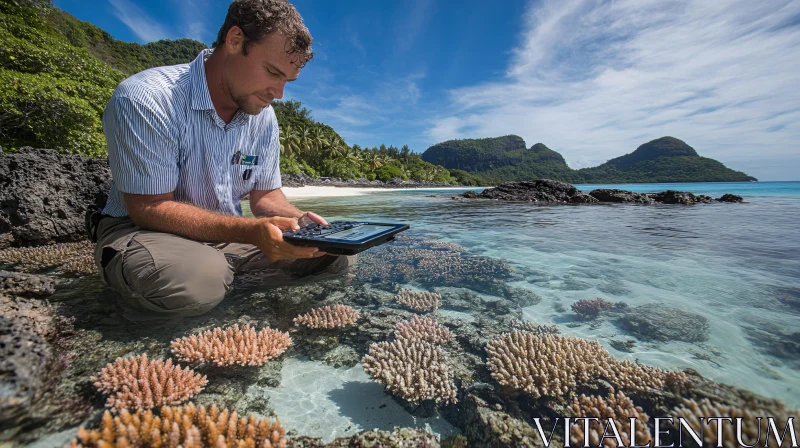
[422,135,756,184]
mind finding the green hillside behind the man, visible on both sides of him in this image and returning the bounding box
[0,0,454,183]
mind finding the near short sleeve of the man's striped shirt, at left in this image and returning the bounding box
[103,95,178,194]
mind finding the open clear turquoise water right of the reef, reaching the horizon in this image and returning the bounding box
[286,182,800,408]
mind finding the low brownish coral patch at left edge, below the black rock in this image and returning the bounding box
[0,241,97,274]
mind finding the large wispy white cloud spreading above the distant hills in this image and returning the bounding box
[427,0,800,178]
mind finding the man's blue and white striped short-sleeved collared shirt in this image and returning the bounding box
[103,50,281,217]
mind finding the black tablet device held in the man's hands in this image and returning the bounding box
[283,221,408,255]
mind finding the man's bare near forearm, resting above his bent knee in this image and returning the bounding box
[128,200,256,244]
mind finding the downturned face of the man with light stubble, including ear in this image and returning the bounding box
[223,27,300,115]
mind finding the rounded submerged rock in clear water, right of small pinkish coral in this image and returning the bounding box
[616,303,709,342]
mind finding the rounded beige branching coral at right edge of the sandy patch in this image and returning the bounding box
[363,339,456,403]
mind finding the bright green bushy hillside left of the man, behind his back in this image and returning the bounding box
[0,0,205,156]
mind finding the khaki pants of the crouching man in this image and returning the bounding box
[94,217,356,320]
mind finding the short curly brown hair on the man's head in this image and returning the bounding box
[212,0,314,67]
